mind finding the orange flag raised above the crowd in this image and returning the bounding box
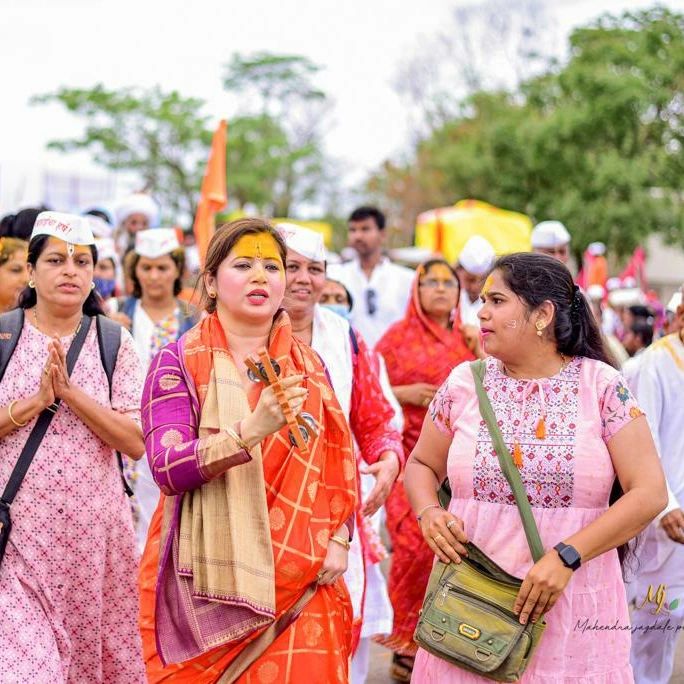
[192,119,228,265]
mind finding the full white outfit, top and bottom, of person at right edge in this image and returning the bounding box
[628,334,684,684]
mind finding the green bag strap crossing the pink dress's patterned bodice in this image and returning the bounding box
[470,359,544,563]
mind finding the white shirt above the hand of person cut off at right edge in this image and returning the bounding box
[636,333,684,517]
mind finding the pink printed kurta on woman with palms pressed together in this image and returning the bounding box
[0,321,145,684]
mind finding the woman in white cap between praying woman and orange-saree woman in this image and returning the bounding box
[119,228,198,551]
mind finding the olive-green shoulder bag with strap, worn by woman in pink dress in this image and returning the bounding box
[414,361,546,682]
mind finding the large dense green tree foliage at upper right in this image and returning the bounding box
[372,8,684,254]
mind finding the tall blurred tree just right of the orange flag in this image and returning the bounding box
[223,52,330,216]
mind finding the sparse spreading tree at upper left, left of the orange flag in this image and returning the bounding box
[32,84,211,218]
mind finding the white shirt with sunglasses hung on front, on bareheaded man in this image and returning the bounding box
[327,257,416,349]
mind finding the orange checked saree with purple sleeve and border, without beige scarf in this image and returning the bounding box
[140,312,356,684]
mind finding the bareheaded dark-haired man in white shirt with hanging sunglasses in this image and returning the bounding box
[328,207,415,349]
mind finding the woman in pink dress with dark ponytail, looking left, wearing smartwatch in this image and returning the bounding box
[405,254,667,684]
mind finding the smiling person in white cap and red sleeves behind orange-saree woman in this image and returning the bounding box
[276,224,403,684]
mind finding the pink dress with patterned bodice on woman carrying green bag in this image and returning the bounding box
[412,358,642,684]
